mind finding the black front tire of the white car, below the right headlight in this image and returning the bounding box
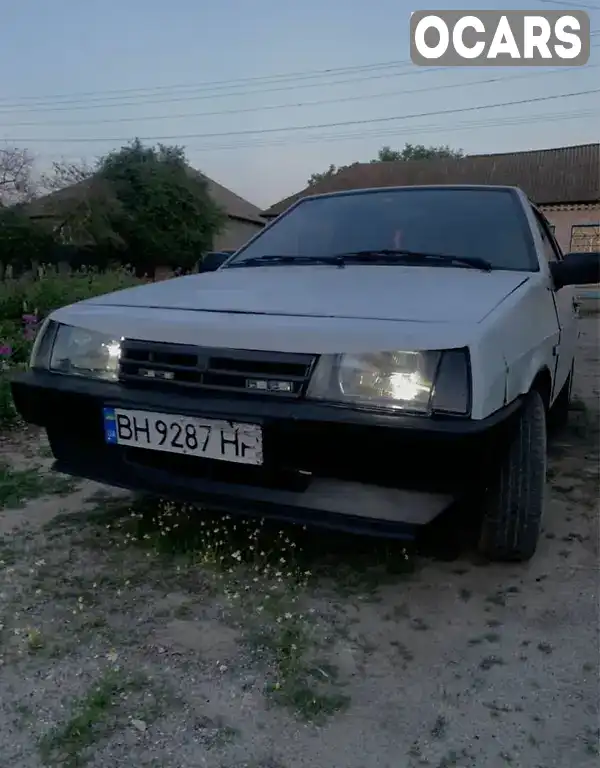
[478,390,547,562]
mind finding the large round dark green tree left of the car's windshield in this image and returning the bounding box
[95,139,225,275]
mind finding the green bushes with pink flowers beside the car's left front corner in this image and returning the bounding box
[0,268,144,425]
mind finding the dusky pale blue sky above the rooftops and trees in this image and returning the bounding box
[0,0,600,207]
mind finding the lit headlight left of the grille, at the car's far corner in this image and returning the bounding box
[36,323,121,381]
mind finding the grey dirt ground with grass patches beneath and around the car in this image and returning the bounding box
[0,318,600,768]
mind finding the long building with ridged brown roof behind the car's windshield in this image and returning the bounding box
[262,144,600,252]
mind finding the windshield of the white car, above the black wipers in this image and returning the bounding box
[231,187,538,271]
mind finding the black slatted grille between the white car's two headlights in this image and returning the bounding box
[119,339,317,398]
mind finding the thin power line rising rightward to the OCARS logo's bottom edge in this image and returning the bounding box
[5,64,600,128]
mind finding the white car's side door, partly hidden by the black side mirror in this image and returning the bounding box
[532,206,579,399]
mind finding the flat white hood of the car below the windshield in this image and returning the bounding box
[82,265,528,324]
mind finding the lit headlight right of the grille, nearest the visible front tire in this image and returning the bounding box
[307,349,470,415]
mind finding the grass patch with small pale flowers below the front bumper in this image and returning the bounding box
[75,499,380,721]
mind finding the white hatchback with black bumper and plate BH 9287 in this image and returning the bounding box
[12,186,600,560]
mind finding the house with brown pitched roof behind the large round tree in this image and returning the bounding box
[22,168,266,250]
